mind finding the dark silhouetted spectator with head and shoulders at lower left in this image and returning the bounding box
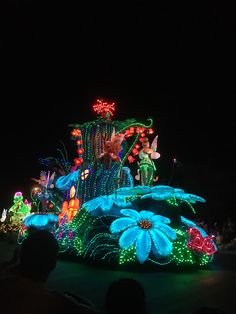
[0,230,98,314]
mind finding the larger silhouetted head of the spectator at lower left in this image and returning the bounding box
[20,230,59,281]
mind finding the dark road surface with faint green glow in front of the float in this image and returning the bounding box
[0,236,236,314]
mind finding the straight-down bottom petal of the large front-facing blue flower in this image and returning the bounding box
[136,230,152,264]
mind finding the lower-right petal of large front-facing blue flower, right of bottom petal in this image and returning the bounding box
[149,229,172,256]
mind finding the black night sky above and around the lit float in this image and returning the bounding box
[0,0,236,223]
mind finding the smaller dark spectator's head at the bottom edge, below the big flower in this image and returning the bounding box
[106,278,147,314]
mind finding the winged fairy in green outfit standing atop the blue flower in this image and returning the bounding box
[135,135,160,186]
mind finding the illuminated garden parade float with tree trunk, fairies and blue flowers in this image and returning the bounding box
[0,100,217,268]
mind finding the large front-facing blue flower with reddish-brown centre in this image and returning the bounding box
[110,209,176,263]
